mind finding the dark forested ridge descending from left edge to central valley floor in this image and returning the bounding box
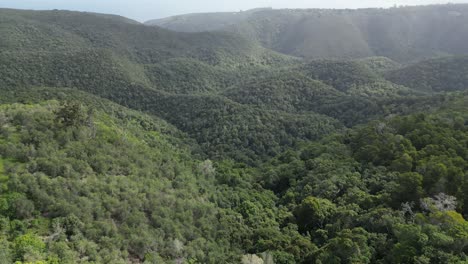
[0,51,340,163]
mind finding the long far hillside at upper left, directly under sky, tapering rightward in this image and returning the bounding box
[0,9,292,65]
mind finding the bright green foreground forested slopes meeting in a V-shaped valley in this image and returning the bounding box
[0,88,468,263]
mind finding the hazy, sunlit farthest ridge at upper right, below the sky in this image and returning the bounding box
[146,4,468,62]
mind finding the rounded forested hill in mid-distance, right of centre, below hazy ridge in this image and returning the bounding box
[222,60,436,127]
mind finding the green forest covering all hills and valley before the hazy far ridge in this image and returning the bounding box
[0,5,468,264]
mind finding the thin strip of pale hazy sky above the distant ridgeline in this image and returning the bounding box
[0,0,468,21]
